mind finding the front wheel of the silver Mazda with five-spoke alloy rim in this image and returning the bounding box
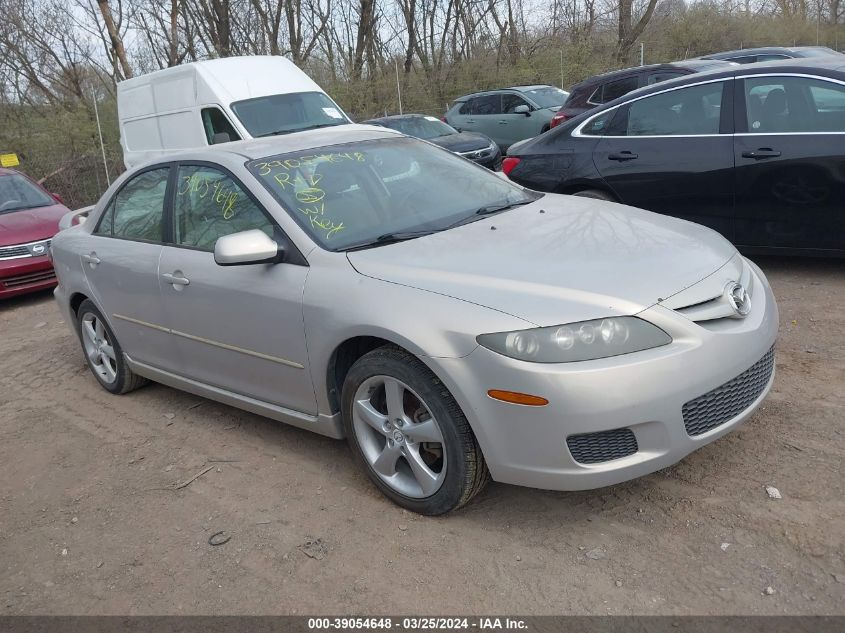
[341,346,489,516]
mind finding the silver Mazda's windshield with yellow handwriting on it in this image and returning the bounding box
[247,137,542,251]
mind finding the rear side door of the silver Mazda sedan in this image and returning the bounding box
[82,167,178,370]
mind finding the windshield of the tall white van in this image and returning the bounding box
[232,92,349,138]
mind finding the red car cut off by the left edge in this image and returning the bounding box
[0,168,69,299]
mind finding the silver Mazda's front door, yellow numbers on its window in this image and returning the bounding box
[159,160,317,414]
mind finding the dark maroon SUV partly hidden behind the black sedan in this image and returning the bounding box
[550,59,731,127]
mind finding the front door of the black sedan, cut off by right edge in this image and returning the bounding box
[735,74,845,250]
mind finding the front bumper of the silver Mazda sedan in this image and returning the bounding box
[430,260,778,490]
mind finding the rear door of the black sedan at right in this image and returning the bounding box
[588,79,734,239]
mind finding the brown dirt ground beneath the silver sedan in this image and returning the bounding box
[0,258,845,615]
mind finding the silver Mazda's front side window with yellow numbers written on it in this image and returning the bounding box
[173,165,273,251]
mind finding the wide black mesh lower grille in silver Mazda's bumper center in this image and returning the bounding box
[682,346,775,437]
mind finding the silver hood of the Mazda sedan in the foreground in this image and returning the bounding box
[348,194,736,326]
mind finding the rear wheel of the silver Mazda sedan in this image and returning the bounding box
[76,299,148,394]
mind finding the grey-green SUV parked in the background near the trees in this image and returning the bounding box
[443,85,569,152]
